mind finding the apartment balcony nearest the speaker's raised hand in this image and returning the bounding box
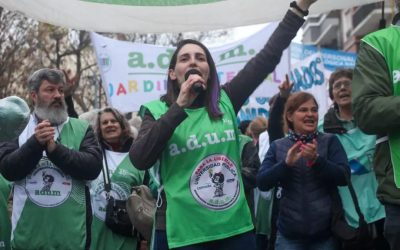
[302,12,339,49]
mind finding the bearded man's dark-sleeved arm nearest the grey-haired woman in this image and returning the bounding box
[47,126,103,180]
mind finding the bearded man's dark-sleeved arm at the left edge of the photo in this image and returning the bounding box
[0,135,44,181]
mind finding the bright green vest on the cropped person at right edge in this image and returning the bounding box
[362,25,400,188]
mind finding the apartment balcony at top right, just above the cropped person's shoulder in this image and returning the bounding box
[351,2,392,37]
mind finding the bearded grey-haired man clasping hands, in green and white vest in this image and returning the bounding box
[0,68,102,250]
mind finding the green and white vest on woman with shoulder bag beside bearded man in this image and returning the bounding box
[90,150,144,250]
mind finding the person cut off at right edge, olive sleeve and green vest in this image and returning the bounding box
[352,0,400,250]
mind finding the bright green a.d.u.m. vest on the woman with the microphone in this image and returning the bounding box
[141,91,253,248]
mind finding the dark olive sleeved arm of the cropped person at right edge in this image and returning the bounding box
[352,42,400,135]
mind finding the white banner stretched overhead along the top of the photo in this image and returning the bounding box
[0,0,379,33]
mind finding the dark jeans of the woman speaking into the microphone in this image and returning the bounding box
[154,230,256,250]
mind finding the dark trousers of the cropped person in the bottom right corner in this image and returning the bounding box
[383,204,400,250]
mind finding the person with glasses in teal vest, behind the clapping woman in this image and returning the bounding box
[322,69,389,250]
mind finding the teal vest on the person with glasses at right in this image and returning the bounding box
[337,128,385,228]
